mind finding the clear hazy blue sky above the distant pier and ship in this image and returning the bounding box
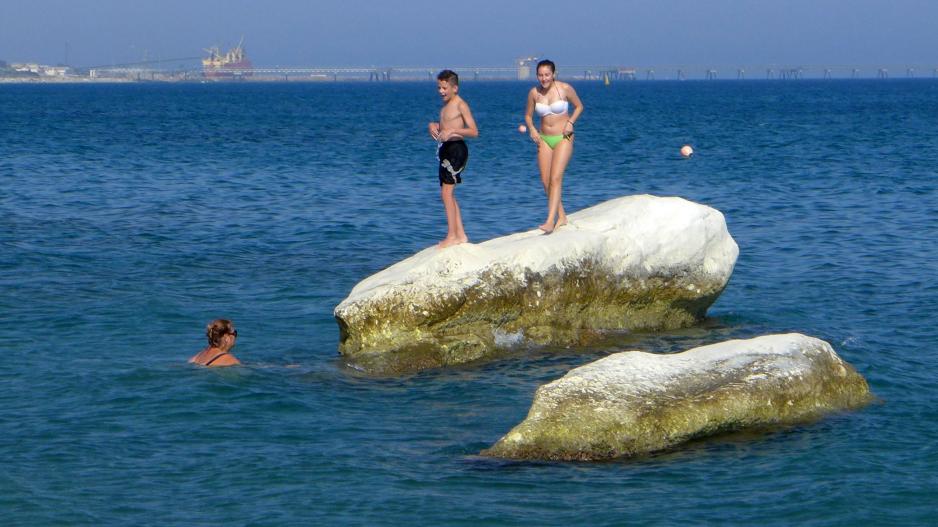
[0,0,938,67]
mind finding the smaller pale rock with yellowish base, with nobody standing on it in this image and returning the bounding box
[482,333,872,460]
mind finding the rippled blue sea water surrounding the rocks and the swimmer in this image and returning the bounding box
[0,79,938,526]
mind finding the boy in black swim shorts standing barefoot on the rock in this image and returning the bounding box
[429,70,479,249]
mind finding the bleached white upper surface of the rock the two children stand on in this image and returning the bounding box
[335,195,739,306]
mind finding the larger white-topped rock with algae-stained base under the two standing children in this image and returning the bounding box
[335,195,739,374]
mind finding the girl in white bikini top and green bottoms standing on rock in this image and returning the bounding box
[524,60,583,234]
